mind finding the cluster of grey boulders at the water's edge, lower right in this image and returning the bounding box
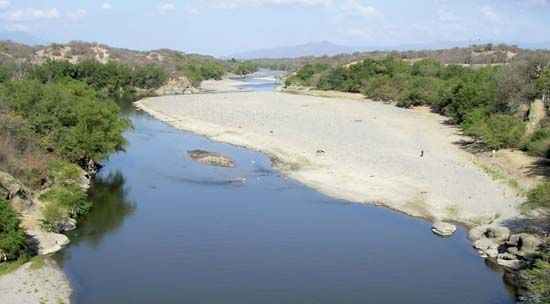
[470,226,543,269]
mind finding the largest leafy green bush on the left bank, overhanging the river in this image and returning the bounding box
[0,81,130,166]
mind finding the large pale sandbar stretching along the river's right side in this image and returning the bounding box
[137,92,522,225]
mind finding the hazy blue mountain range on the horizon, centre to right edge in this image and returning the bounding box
[222,41,550,60]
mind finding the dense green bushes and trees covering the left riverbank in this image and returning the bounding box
[0,61,137,260]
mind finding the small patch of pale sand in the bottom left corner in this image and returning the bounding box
[0,258,71,304]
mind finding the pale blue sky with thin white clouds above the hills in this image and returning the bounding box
[0,0,550,56]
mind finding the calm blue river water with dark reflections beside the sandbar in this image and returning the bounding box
[58,72,514,304]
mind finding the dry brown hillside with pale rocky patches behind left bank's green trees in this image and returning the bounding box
[0,41,257,95]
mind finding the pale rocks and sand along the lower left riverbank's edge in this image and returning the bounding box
[0,171,90,303]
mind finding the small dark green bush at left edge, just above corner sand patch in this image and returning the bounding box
[0,198,27,261]
